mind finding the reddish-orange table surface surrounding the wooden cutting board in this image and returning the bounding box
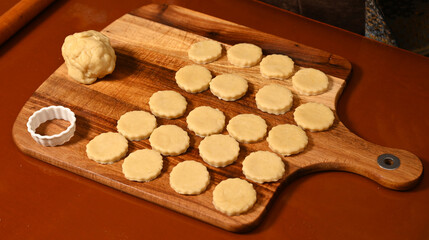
[0,0,429,240]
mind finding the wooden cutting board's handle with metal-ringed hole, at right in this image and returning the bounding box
[297,123,423,190]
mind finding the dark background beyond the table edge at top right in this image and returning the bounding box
[260,0,429,56]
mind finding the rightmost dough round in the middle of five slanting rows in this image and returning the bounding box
[267,124,308,156]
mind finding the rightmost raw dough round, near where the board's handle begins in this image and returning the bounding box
[293,102,335,132]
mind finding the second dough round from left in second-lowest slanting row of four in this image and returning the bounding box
[149,125,189,156]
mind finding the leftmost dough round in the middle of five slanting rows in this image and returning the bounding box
[149,90,188,119]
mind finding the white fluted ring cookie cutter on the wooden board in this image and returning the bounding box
[27,106,76,147]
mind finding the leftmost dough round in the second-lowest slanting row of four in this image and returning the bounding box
[116,111,156,141]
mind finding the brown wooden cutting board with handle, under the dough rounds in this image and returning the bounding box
[13,4,423,231]
